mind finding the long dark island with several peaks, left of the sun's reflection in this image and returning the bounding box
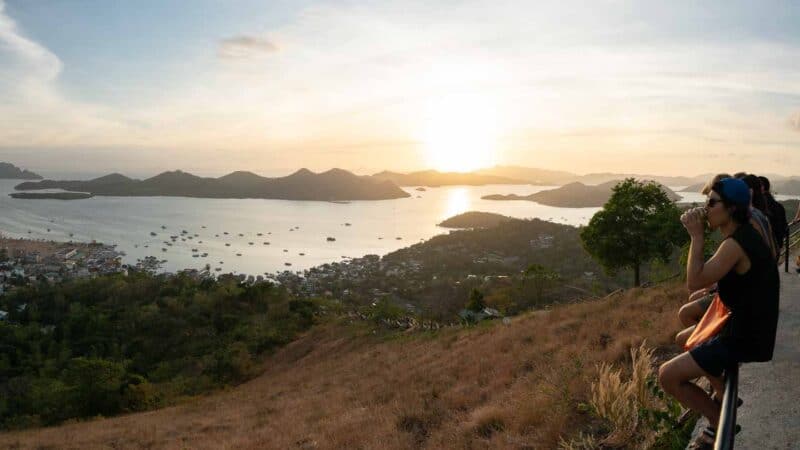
[15,169,410,201]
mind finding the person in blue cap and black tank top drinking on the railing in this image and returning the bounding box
[658,178,779,449]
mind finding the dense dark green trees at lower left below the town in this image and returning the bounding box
[0,273,320,429]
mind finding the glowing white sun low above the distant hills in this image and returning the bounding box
[422,94,497,172]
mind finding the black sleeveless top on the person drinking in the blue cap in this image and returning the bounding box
[718,223,780,361]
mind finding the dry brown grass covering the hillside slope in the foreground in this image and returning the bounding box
[0,283,685,449]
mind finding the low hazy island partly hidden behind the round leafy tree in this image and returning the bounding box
[481,180,681,208]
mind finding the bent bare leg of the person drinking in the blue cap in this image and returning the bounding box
[658,352,720,427]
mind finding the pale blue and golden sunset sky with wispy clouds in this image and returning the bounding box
[0,0,800,176]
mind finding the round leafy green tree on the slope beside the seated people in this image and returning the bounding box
[581,178,687,286]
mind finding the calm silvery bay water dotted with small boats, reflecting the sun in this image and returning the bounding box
[0,180,792,275]
